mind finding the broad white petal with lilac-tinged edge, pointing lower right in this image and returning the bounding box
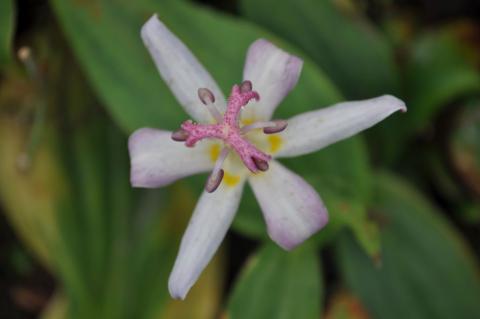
[250,161,328,250]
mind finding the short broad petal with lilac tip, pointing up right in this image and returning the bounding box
[243,39,303,120]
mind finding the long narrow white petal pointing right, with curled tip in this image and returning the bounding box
[275,95,407,157]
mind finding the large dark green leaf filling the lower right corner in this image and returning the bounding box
[337,174,480,319]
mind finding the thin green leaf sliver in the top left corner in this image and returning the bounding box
[0,0,15,69]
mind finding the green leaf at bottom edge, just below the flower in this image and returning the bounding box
[227,244,323,319]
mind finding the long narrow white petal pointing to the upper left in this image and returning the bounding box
[141,15,226,123]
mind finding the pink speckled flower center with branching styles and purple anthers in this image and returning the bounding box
[172,81,287,192]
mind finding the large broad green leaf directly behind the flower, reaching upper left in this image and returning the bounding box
[52,0,376,249]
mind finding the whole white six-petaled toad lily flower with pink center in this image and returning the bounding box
[129,16,406,299]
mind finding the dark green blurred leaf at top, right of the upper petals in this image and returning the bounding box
[240,0,399,99]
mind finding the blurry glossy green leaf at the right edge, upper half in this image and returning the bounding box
[406,29,480,129]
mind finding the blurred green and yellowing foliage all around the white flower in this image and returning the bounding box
[0,0,480,319]
